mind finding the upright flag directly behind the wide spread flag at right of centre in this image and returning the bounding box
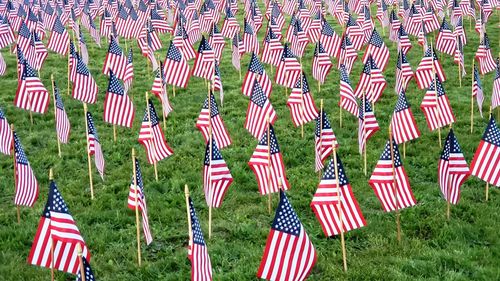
[391,90,420,144]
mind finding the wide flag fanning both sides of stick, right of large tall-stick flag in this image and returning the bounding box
[368,141,417,212]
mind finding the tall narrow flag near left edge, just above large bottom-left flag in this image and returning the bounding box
[12,132,38,207]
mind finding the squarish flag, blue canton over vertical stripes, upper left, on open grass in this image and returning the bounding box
[104,70,135,128]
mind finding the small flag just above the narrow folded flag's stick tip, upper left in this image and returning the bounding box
[72,54,99,103]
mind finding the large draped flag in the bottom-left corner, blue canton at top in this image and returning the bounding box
[28,180,90,274]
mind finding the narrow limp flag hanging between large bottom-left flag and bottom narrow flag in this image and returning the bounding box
[127,158,153,245]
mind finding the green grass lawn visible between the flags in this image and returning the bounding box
[0,7,500,280]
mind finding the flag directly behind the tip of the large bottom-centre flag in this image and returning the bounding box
[248,125,290,195]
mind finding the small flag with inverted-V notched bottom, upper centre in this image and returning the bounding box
[241,53,272,98]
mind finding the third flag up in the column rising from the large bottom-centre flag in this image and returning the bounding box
[245,80,277,139]
